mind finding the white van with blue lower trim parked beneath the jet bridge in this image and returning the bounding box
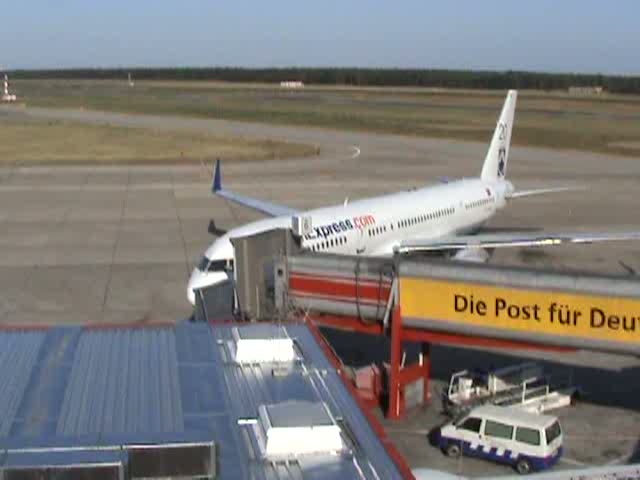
[436,405,562,474]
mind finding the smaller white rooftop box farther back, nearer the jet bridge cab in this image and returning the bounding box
[233,328,296,363]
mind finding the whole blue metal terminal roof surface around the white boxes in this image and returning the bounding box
[0,324,400,479]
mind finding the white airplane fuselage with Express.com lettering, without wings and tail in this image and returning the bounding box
[187,179,512,303]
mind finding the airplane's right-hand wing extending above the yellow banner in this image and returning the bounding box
[397,231,640,253]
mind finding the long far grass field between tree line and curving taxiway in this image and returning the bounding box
[14,80,640,156]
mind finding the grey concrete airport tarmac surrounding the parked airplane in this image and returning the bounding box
[0,103,640,474]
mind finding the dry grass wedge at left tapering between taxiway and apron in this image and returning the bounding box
[0,117,316,165]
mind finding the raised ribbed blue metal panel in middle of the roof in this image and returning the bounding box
[56,328,184,436]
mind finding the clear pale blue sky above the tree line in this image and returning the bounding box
[0,0,640,75]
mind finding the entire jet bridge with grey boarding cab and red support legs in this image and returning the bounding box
[196,229,640,418]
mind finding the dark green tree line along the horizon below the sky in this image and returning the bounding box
[11,67,640,94]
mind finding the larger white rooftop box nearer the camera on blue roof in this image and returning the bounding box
[258,401,344,458]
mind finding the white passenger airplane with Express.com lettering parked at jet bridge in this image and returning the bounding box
[187,90,640,304]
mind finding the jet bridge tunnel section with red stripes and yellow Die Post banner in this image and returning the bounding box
[276,254,640,355]
